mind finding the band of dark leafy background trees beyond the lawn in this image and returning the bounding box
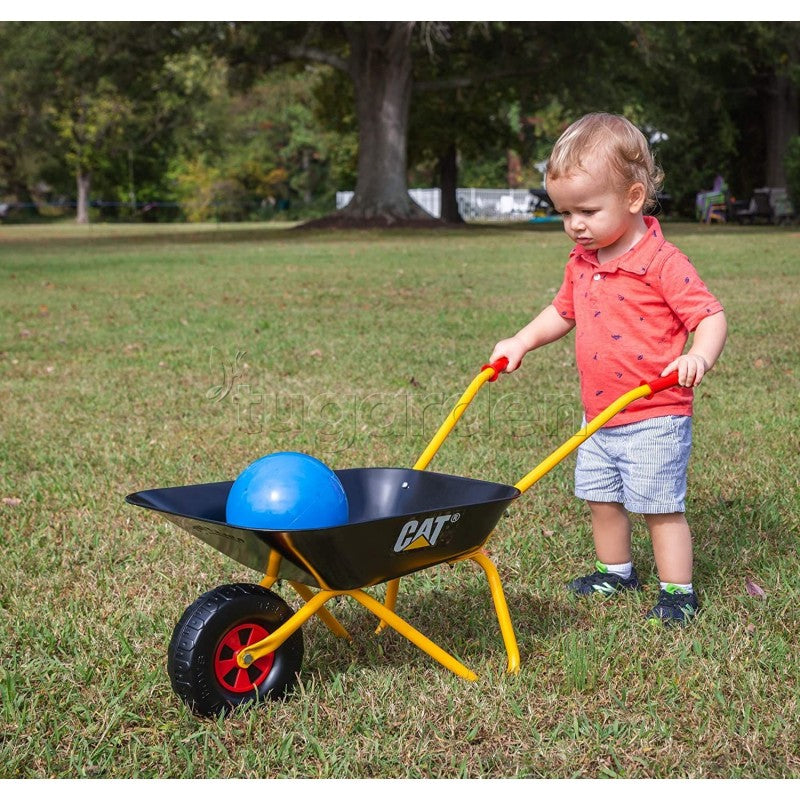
[0,22,800,222]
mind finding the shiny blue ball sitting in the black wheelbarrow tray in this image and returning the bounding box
[225,453,349,530]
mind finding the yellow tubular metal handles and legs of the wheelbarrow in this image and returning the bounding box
[237,366,652,681]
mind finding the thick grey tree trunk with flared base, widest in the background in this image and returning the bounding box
[340,22,432,225]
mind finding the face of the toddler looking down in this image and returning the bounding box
[547,162,644,257]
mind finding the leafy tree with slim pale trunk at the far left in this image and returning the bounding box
[0,22,215,222]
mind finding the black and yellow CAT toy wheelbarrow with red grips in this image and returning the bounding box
[126,358,678,716]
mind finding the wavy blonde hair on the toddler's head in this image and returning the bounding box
[546,112,664,210]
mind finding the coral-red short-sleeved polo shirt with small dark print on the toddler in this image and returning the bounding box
[553,212,722,426]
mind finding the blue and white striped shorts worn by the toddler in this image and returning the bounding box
[575,416,692,514]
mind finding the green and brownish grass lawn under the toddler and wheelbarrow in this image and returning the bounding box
[0,217,800,778]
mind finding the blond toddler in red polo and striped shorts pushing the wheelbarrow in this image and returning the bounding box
[491,113,727,624]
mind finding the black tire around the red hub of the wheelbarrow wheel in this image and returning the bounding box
[167,583,303,717]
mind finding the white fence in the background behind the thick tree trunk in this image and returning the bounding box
[336,189,542,220]
